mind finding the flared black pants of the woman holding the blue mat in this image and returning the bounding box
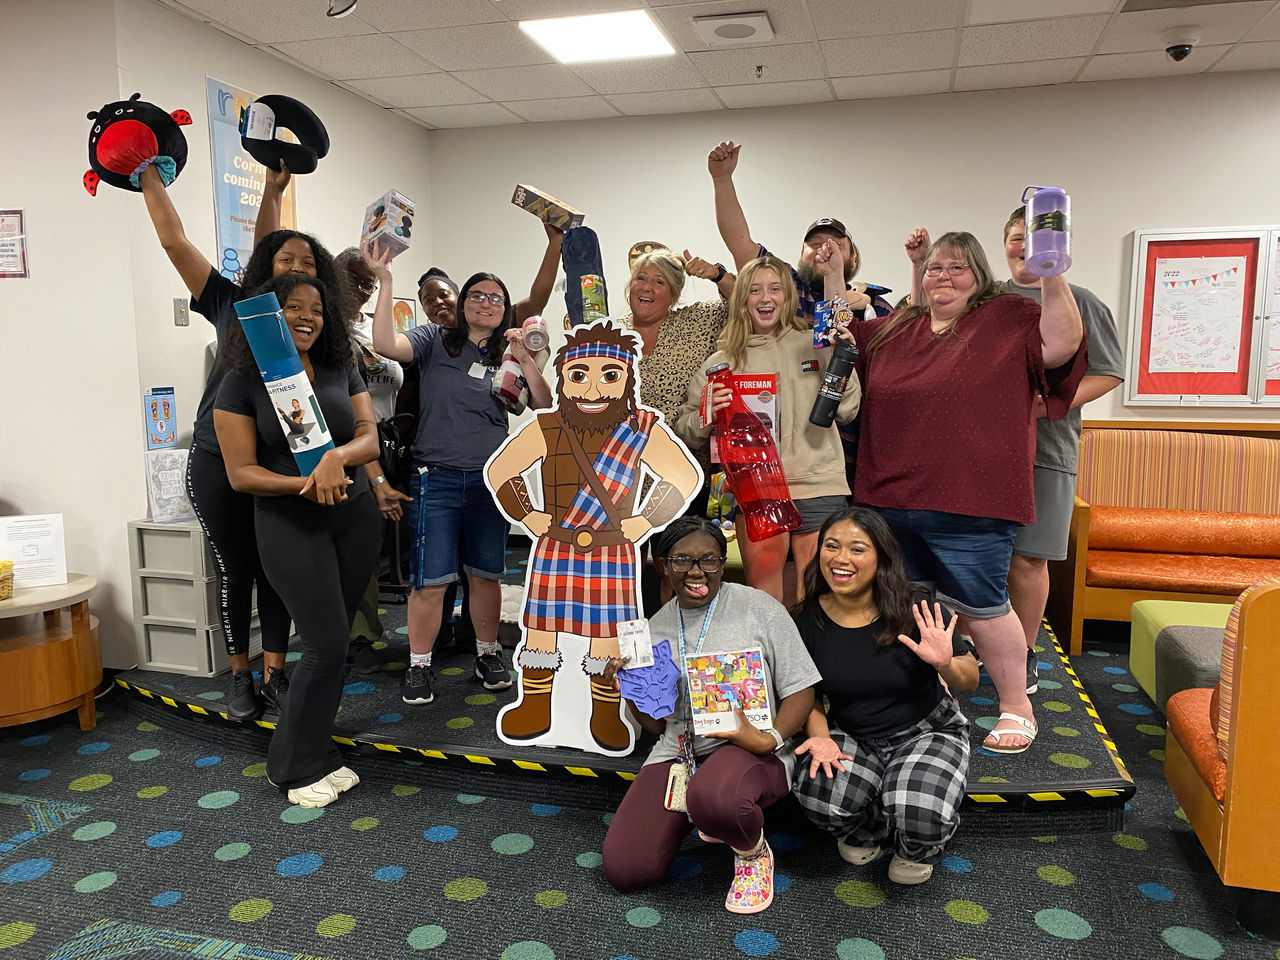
[255,493,381,788]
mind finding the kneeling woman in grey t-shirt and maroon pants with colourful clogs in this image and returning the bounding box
[603,517,819,914]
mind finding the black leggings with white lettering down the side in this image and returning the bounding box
[187,447,289,655]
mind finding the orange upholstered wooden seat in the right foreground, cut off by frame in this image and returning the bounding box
[1165,579,1280,938]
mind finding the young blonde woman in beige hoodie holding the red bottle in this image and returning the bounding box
[676,256,861,600]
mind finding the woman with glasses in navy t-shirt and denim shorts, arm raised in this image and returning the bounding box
[362,243,552,704]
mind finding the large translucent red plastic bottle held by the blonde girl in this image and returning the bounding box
[707,364,800,543]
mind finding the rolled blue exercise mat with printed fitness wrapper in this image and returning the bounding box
[236,293,333,476]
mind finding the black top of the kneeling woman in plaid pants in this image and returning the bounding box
[795,608,969,737]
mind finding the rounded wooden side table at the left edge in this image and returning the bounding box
[0,573,102,730]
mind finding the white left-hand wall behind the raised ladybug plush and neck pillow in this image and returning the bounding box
[0,0,431,667]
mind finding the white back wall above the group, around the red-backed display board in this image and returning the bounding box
[431,73,1280,420]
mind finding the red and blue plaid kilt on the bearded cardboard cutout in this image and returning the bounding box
[525,536,640,637]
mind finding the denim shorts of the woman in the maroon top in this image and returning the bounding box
[877,507,1021,620]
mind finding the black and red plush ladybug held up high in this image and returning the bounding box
[84,93,191,197]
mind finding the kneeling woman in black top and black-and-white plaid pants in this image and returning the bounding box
[794,507,978,883]
